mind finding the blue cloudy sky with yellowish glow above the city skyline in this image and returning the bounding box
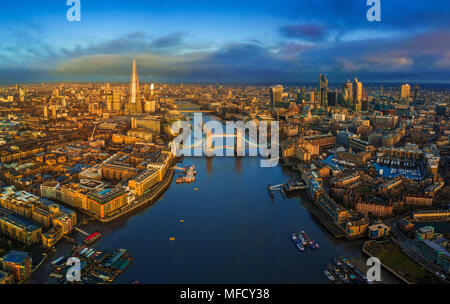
[0,0,450,84]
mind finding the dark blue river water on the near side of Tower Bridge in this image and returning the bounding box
[29,113,396,283]
